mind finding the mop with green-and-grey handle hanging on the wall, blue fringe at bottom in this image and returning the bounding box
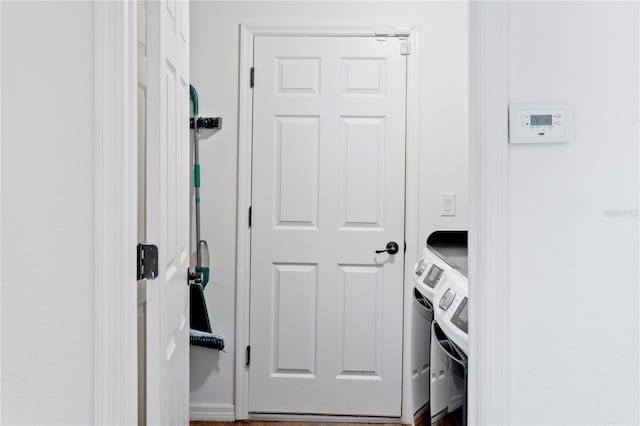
[189,86,224,351]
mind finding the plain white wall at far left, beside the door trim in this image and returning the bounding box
[0,1,94,425]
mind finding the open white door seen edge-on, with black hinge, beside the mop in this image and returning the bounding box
[147,0,189,425]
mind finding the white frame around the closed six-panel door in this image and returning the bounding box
[235,24,422,423]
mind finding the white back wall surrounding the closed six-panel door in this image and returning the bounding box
[191,1,468,408]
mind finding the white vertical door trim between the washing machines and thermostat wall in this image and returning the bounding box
[468,1,511,425]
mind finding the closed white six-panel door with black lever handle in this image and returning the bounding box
[249,37,406,416]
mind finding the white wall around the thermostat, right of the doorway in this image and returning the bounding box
[509,2,640,424]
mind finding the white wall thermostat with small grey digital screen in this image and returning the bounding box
[509,103,573,143]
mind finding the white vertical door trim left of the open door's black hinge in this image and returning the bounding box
[93,2,138,425]
